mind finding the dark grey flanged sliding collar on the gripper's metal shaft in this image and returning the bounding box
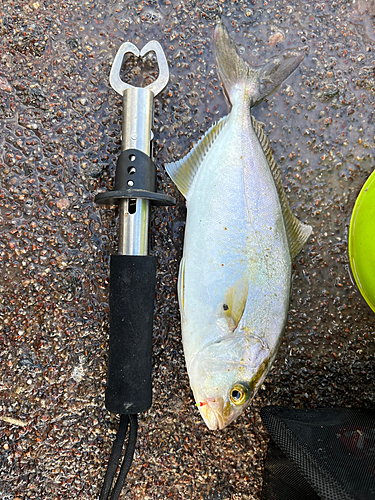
[95,149,176,205]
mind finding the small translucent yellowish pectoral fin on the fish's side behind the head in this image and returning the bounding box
[221,276,249,332]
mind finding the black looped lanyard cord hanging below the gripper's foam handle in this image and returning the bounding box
[99,414,138,500]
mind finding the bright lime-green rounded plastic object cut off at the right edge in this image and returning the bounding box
[349,170,375,312]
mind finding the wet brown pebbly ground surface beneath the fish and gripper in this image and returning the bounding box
[0,0,375,500]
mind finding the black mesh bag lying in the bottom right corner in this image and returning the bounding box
[261,406,375,500]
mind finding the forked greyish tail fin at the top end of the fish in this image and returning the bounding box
[214,22,306,106]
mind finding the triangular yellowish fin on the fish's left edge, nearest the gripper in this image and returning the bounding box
[165,116,228,198]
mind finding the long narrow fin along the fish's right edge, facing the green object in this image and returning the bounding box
[251,116,312,259]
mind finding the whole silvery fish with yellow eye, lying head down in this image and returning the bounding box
[165,21,312,430]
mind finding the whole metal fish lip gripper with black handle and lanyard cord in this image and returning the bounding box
[95,40,176,500]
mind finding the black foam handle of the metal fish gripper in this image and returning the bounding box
[105,255,156,415]
